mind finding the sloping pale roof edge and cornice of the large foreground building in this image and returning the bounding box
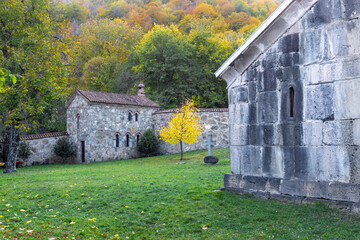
[215,0,318,79]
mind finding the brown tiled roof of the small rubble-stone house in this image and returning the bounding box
[76,89,160,108]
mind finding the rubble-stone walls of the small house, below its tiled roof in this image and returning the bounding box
[67,95,157,162]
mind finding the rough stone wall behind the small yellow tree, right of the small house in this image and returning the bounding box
[153,108,229,154]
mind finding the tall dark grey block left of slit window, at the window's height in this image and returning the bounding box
[258,91,279,123]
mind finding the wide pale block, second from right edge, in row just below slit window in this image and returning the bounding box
[322,120,354,145]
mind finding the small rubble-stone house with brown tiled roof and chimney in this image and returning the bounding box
[66,84,160,162]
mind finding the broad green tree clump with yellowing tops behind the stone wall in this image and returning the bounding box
[135,25,233,108]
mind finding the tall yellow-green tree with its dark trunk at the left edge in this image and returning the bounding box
[0,0,67,173]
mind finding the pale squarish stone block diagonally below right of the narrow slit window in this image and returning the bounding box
[302,121,323,146]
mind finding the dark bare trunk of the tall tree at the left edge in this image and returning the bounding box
[4,123,20,173]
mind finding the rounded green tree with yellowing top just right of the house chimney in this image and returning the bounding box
[135,25,196,107]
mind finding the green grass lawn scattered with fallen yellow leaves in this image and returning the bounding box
[0,149,360,239]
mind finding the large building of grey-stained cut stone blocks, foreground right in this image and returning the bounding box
[215,0,360,206]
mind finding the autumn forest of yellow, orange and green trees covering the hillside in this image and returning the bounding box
[0,0,281,135]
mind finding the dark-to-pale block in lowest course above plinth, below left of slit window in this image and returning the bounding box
[262,147,285,178]
